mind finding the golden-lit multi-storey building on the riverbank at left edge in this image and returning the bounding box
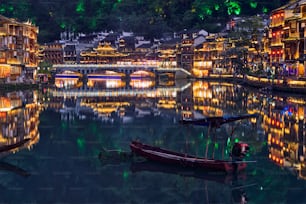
[0,15,38,81]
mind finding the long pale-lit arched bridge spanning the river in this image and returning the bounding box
[53,64,191,78]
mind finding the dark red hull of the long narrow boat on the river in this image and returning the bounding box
[130,141,248,172]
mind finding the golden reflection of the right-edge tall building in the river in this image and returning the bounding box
[263,97,306,178]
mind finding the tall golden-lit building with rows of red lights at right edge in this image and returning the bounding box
[268,0,306,76]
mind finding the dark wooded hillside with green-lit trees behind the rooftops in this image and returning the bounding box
[0,0,288,42]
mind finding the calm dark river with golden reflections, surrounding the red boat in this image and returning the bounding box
[0,81,306,204]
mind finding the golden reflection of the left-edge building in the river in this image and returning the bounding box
[0,92,40,154]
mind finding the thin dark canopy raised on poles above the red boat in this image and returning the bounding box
[180,114,258,127]
